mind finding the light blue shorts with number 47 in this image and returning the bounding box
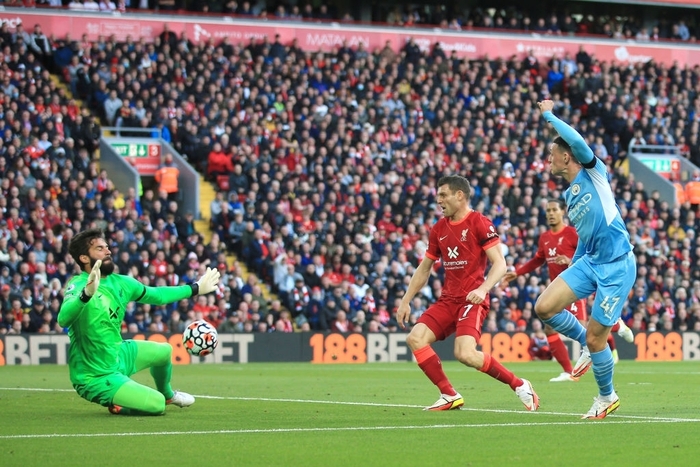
[559,251,637,326]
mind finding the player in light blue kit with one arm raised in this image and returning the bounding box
[535,100,637,419]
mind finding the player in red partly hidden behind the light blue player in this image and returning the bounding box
[504,199,634,381]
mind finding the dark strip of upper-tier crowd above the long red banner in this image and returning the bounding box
[5,0,699,42]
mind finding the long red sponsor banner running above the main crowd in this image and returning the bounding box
[0,9,700,66]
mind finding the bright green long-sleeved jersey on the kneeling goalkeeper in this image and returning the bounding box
[58,272,192,384]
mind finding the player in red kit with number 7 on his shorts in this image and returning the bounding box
[396,175,539,411]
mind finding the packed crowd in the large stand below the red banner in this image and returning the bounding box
[0,19,700,340]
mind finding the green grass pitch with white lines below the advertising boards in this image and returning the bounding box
[0,361,700,467]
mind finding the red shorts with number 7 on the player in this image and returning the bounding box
[418,302,489,343]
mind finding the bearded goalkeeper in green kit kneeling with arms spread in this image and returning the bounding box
[58,229,220,415]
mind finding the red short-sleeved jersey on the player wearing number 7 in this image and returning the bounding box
[425,211,500,302]
